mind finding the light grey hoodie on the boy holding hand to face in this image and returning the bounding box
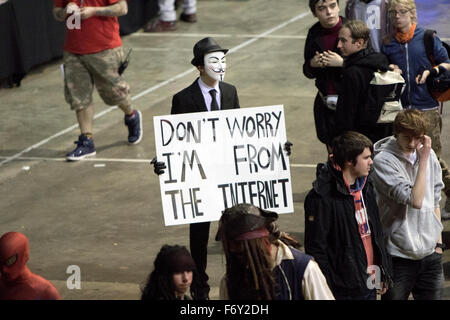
[372,137,443,260]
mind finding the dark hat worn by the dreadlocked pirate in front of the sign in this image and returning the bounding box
[216,203,278,241]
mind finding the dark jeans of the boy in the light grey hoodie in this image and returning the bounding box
[381,252,444,300]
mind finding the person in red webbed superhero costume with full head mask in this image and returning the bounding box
[0,232,61,300]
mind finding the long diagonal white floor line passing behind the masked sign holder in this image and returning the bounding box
[0,12,310,166]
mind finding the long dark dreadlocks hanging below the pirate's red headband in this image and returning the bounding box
[223,238,275,300]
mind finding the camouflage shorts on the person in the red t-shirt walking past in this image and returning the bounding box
[64,47,131,110]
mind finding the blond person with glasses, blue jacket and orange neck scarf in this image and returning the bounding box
[381,0,450,222]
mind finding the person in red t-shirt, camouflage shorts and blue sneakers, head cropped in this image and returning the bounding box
[53,0,142,161]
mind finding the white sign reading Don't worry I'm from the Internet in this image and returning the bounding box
[153,105,294,226]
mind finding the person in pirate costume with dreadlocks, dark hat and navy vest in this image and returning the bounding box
[216,204,334,300]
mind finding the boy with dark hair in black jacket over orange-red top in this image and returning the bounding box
[305,132,391,300]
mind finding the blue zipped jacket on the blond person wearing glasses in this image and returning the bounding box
[381,27,450,110]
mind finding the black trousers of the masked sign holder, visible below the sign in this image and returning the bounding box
[189,222,211,300]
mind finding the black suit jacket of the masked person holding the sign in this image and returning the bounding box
[170,78,239,114]
